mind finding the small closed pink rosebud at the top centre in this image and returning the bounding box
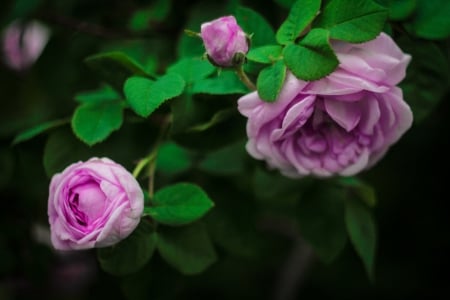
[200,16,248,67]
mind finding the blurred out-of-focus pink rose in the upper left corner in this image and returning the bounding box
[3,21,50,71]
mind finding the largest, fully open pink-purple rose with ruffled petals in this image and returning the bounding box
[238,33,413,177]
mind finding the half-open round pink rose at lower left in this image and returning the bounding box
[48,158,144,250]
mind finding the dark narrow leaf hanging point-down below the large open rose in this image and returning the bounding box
[345,199,377,280]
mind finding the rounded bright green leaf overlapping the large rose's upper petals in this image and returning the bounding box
[283,28,339,81]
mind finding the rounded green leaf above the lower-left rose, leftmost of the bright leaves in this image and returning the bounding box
[72,101,123,146]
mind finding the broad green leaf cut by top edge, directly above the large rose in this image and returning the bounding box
[315,0,388,43]
